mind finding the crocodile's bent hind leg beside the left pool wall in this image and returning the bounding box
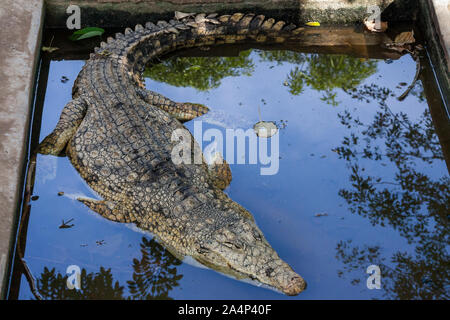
[37,98,87,156]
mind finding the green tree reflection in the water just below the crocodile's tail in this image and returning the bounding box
[144,50,377,106]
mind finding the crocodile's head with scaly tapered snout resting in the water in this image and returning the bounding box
[193,218,306,296]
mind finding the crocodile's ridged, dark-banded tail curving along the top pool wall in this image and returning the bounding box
[90,12,304,75]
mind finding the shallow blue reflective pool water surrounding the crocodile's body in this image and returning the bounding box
[12,50,450,299]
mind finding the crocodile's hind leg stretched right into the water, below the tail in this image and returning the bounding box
[138,88,209,122]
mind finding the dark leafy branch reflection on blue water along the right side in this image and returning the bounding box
[335,84,450,299]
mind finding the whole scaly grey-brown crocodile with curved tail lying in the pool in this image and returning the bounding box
[37,12,306,295]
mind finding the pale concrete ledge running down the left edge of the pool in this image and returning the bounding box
[0,0,43,297]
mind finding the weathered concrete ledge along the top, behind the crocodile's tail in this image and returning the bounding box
[45,0,400,28]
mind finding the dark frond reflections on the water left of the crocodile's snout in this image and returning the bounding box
[36,238,183,300]
